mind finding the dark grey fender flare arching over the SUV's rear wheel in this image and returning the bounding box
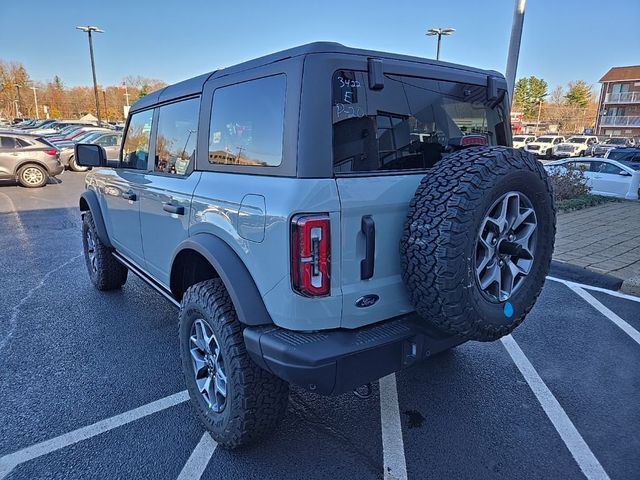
[171,233,273,326]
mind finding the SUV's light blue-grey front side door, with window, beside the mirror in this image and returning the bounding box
[96,110,153,267]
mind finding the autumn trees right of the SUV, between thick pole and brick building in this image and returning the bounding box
[511,75,598,132]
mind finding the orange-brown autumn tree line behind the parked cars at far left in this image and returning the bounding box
[0,59,167,121]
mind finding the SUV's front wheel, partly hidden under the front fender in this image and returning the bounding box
[82,211,129,290]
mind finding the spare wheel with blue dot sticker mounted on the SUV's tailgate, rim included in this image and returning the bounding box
[400,147,555,341]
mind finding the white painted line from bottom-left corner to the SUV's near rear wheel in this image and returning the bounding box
[0,390,189,480]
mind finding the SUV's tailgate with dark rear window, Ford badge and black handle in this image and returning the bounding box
[333,71,507,327]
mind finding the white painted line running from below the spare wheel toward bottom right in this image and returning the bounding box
[501,335,609,480]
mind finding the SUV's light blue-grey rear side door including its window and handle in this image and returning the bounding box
[140,97,200,287]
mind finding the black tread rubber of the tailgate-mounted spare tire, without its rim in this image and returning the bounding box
[400,147,555,341]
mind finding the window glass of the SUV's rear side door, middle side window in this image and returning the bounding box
[154,98,200,175]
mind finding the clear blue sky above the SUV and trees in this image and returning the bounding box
[0,0,640,88]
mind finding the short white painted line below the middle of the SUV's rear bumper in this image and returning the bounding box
[379,373,407,480]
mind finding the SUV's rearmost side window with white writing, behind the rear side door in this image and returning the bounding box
[209,75,286,167]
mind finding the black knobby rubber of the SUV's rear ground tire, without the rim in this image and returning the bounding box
[179,279,289,448]
